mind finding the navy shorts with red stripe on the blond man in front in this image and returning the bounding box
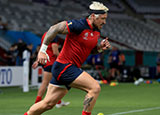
[50,61,83,90]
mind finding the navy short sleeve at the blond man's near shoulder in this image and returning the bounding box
[67,20,85,34]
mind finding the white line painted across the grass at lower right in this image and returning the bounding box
[109,107,160,115]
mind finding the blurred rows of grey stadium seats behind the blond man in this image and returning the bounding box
[0,0,160,56]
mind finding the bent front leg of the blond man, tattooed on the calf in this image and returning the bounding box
[70,72,101,112]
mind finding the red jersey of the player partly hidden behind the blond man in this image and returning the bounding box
[41,32,58,67]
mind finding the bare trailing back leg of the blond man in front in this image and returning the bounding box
[27,84,68,115]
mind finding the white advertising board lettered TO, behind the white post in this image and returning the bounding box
[0,66,43,87]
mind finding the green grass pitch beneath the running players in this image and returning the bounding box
[0,83,160,115]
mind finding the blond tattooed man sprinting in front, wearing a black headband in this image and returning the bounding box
[24,2,110,115]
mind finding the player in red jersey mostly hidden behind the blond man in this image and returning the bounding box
[32,33,70,108]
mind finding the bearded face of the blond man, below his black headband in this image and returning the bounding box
[93,13,107,30]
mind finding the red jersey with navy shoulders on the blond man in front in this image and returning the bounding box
[56,19,100,67]
